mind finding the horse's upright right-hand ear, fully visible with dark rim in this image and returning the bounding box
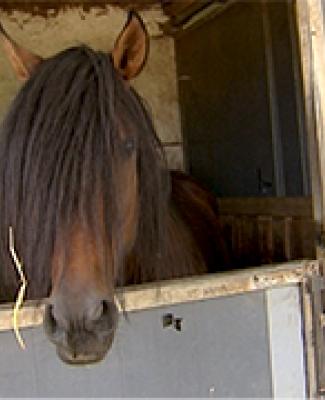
[112,11,149,80]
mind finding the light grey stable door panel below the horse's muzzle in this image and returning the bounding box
[0,292,272,398]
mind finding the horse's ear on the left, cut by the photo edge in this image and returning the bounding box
[0,23,42,81]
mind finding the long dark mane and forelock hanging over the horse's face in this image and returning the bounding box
[0,46,169,300]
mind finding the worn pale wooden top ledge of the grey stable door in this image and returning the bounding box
[0,261,318,331]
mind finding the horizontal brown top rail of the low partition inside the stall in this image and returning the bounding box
[217,197,312,218]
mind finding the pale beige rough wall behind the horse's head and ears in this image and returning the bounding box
[0,6,182,167]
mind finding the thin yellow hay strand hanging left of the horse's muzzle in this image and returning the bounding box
[9,226,27,350]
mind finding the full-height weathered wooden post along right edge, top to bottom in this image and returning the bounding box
[296,0,325,398]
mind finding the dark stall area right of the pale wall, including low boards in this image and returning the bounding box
[175,1,315,268]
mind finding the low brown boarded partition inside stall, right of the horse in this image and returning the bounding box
[218,197,316,268]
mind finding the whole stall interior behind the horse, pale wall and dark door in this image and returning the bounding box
[0,0,315,290]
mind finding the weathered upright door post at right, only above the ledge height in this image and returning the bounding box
[295,0,325,258]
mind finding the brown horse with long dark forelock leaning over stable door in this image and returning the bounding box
[0,12,227,363]
